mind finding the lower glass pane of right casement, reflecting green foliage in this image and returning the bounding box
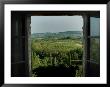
[90,38,100,63]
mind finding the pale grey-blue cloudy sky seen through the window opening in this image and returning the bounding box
[31,16,83,33]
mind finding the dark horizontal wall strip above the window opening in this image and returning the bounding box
[12,11,100,17]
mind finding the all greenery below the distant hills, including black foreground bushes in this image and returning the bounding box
[31,38,83,77]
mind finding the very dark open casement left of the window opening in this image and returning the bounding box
[11,12,29,77]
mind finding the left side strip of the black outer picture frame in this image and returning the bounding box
[0,3,4,86]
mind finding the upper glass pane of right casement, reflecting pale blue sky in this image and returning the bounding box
[90,17,100,36]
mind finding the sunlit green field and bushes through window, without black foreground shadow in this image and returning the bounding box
[31,38,83,76]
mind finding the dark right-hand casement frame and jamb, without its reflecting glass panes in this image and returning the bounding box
[83,14,100,77]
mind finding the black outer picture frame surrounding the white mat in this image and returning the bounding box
[0,0,110,87]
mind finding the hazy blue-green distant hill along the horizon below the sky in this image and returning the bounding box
[31,31,82,38]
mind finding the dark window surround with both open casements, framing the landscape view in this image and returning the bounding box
[11,11,100,77]
